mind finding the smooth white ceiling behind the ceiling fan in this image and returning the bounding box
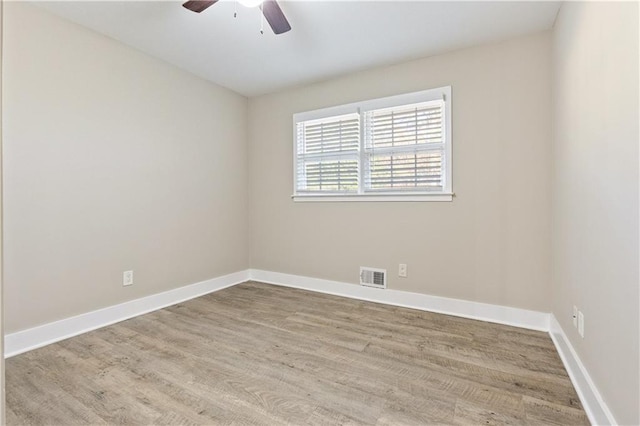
[33,0,561,96]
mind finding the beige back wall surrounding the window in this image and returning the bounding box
[249,33,551,312]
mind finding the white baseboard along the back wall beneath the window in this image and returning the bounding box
[249,269,549,331]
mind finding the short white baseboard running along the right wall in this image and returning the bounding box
[549,314,618,425]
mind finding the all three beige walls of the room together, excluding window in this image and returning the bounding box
[0,2,640,424]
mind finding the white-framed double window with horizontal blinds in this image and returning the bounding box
[293,87,452,201]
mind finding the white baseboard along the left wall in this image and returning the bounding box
[4,270,249,358]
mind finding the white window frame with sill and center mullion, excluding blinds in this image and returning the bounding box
[291,86,454,202]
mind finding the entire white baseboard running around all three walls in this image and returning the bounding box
[4,269,617,425]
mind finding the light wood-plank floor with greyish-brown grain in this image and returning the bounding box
[6,283,588,425]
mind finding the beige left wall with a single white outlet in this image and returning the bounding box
[3,2,249,333]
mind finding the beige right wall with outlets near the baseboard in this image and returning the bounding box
[552,2,640,424]
